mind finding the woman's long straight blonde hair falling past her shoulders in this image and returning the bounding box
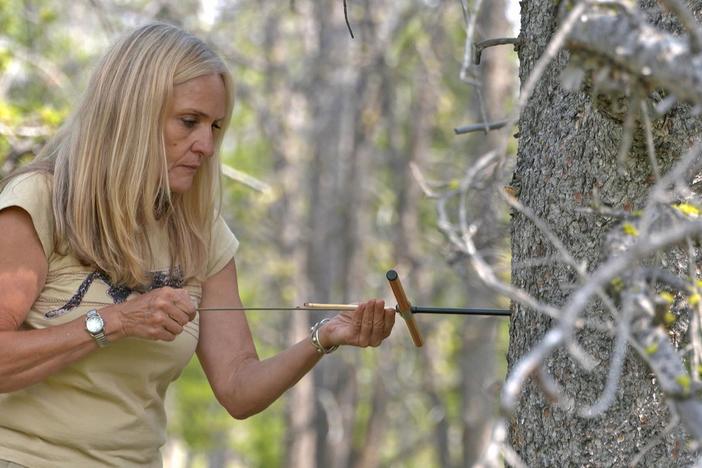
[6,23,233,287]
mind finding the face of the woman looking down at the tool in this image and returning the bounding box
[163,74,226,193]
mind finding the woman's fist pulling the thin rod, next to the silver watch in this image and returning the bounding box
[107,287,196,341]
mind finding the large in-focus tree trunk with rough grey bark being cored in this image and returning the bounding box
[509,0,699,466]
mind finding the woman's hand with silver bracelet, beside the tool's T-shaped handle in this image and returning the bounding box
[319,299,395,349]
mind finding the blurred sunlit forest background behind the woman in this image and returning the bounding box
[0,0,517,468]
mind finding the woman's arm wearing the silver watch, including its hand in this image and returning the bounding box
[0,207,195,393]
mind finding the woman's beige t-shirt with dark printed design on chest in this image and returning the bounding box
[0,173,238,468]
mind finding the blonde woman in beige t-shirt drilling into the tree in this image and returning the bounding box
[0,24,394,468]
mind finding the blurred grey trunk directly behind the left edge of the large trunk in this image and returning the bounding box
[460,0,517,467]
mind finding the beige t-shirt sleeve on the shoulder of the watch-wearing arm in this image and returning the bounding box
[0,172,54,258]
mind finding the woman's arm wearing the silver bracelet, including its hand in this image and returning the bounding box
[197,260,395,419]
